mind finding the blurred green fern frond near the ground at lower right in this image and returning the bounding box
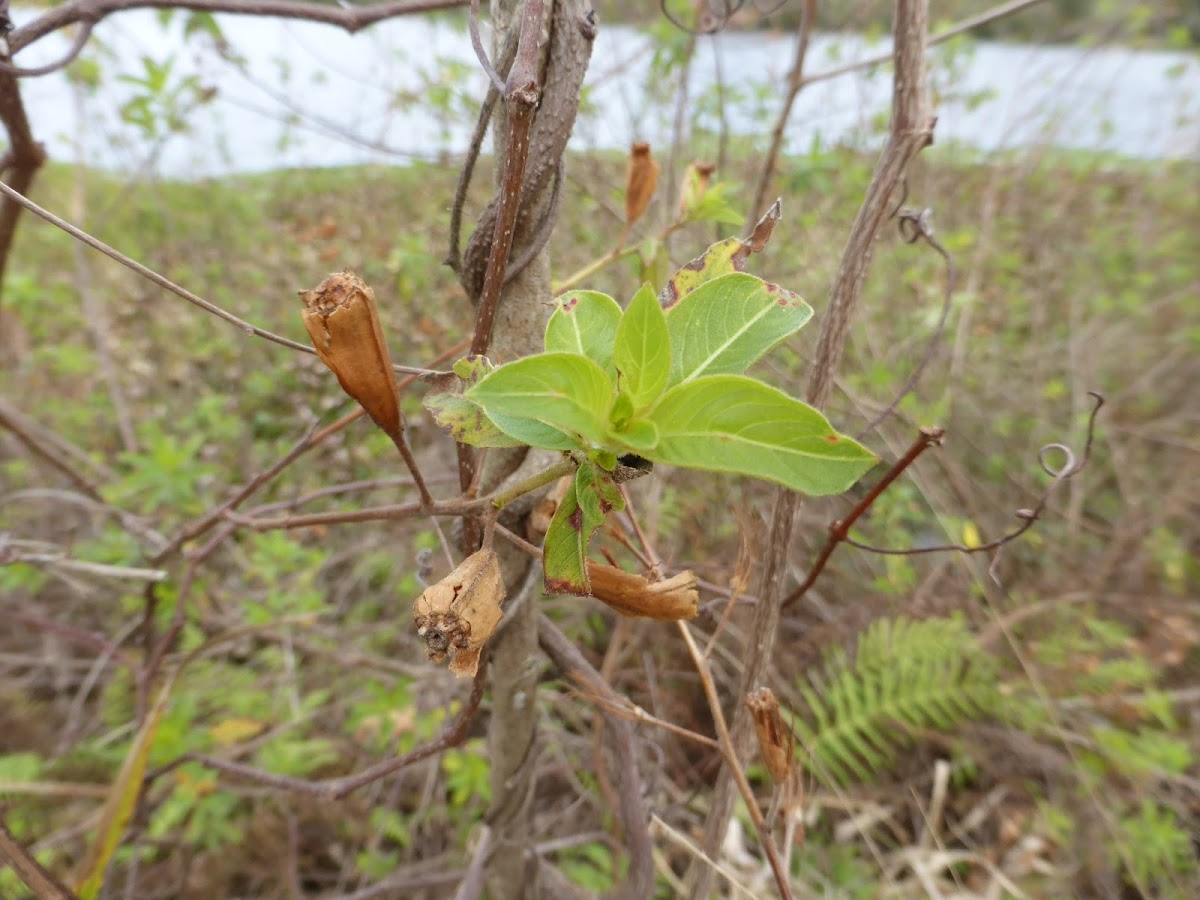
[796,616,997,785]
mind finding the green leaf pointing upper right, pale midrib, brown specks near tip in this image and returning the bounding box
[666,272,812,385]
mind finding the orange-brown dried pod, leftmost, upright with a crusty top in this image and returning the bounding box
[300,272,403,437]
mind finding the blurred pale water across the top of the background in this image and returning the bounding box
[13,10,1200,176]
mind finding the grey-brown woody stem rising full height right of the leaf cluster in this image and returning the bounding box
[688,0,935,898]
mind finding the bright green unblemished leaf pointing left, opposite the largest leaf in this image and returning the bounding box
[466,353,613,450]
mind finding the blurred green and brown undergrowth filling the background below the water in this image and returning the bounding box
[0,4,1200,898]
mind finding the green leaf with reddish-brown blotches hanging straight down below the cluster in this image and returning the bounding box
[542,462,625,596]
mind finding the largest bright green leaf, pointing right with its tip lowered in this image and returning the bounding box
[642,376,876,494]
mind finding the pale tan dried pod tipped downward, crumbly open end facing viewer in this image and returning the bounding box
[413,550,504,677]
